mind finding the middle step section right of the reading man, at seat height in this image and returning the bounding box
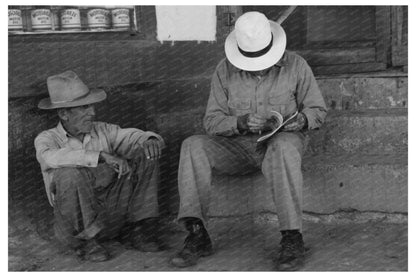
[307,109,408,155]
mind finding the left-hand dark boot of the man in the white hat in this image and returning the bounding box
[170,217,213,267]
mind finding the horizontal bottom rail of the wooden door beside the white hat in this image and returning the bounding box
[296,48,375,65]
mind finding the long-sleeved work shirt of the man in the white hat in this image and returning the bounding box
[204,51,327,136]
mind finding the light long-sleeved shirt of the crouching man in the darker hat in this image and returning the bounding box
[35,122,163,204]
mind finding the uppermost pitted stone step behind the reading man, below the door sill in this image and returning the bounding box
[142,75,408,116]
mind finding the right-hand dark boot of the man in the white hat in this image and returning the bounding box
[277,231,305,271]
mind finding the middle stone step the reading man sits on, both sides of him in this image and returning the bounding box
[153,109,408,155]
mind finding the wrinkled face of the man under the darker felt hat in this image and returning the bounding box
[63,105,95,134]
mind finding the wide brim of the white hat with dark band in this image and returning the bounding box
[224,20,286,71]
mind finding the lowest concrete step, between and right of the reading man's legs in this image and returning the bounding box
[209,153,407,216]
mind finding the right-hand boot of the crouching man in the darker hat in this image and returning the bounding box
[130,218,166,252]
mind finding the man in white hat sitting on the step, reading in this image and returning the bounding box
[171,12,327,270]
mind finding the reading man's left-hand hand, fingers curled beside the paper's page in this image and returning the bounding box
[237,114,276,134]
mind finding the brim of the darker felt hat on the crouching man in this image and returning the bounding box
[38,89,107,110]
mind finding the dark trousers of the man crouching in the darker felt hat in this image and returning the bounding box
[51,153,159,248]
